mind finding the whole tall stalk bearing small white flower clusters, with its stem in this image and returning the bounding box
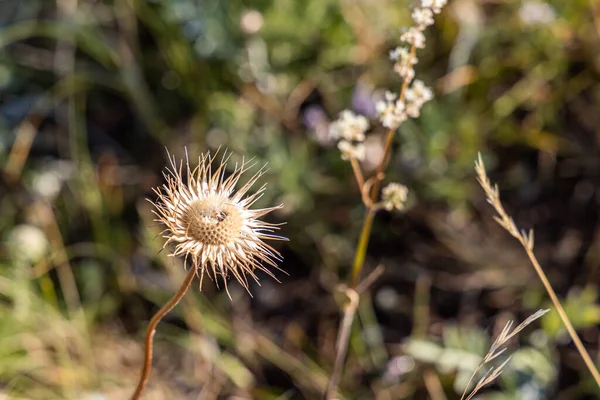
[326,0,447,399]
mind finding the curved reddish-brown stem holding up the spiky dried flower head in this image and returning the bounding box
[131,264,198,400]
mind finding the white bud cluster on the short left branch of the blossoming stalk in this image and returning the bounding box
[329,110,369,161]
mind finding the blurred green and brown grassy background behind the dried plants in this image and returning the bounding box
[0,0,600,400]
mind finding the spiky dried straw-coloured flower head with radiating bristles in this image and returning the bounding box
[151,151,287,295]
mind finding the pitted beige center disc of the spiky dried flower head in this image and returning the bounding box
[183,199,244,246]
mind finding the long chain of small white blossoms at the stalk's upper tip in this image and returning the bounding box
[376,0,447,130]
